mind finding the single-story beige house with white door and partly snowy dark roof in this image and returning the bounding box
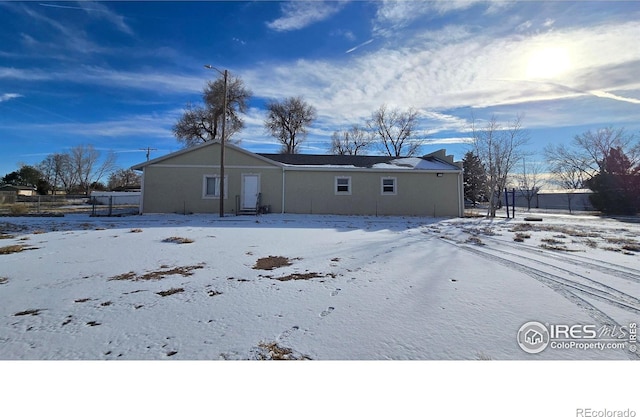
[132,142,464,217]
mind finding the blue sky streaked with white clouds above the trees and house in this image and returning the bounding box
[0,0,640,175]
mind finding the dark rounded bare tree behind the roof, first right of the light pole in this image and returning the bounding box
[264,97,316,154]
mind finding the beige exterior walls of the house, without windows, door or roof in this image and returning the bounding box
[142,144,462,217]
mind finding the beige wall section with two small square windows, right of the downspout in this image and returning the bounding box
[285,170,461,217]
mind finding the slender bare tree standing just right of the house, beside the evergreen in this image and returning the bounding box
[471,116,529,217]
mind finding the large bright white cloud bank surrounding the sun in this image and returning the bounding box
[241,16,640,132]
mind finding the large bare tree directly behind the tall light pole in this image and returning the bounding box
[173,77,252,147]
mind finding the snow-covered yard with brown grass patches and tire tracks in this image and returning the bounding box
[0,210,640,360]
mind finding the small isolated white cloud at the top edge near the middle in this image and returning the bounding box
[267,1,345,32]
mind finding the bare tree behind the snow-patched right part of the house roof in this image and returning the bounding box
[367,104,423,158]
